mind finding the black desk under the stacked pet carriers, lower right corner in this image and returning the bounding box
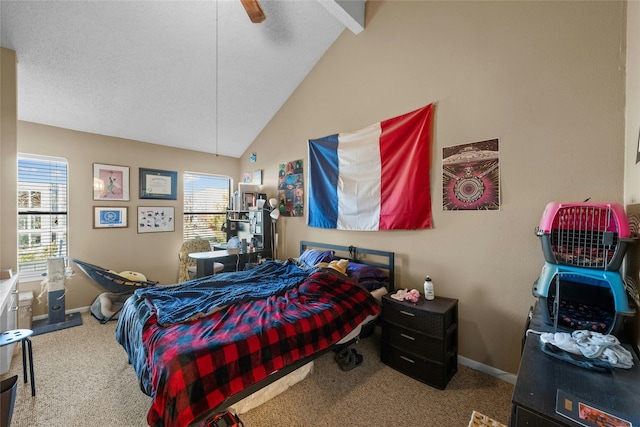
[510,304,640,427]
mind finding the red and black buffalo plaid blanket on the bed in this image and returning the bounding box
[142,270,379,426]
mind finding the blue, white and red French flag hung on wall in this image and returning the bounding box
[307,104,434,231]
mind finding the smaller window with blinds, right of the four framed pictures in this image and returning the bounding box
[183,172,231,245]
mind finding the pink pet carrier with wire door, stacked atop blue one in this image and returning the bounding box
[536,202,632,271]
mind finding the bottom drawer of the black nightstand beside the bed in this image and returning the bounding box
[381,345,458,389]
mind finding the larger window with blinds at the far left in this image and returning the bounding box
[18,154,68,277]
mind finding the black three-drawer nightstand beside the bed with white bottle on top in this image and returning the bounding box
[380,295,458,389]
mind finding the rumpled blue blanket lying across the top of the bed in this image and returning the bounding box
[135,261,310,325]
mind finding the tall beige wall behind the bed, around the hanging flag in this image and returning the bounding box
[241,0,624,372]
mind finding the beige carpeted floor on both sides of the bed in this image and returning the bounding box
[0,313,513,427]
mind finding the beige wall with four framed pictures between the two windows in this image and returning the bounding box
[18,122,238,316]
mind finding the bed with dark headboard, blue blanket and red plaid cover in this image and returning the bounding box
[116,242,395,426]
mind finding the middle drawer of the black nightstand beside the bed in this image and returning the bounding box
[382,322,454,361]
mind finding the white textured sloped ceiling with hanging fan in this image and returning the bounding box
[0,0,364,157]
